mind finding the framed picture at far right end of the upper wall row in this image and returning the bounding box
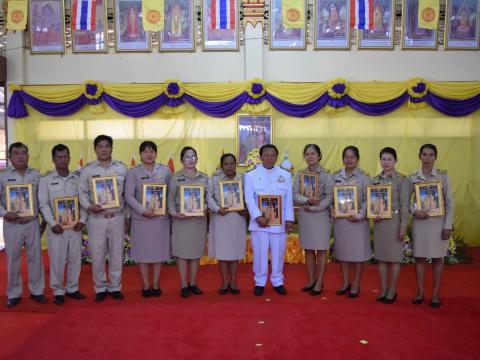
[445,0,480,50]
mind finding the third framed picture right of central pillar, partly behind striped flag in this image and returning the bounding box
[357,0,395,50]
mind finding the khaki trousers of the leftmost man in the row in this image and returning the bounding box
[3,219,45,299]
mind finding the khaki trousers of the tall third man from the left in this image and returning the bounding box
[87,212,125,293]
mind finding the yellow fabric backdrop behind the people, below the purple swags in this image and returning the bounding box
[7,83,480,246]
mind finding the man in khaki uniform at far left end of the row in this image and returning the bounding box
[0,142,47,307]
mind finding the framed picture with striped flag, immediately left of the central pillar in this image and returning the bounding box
[202,0,238,51]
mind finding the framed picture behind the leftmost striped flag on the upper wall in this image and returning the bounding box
[70,0,108,53]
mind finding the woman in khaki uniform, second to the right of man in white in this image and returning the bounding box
[332,146,372,298]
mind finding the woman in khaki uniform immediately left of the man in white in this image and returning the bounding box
[207,154,247,295]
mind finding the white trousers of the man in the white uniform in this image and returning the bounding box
[251,231,287,287]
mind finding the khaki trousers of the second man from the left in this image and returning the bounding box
[47,228,82,296]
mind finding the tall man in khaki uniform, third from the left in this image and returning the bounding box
[78,135,127,302]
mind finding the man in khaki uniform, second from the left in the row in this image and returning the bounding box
[38,144,87,305]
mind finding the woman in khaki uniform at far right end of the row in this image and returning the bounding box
[410,144,453,308]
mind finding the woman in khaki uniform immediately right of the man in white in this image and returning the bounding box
[293,144,333,295]
